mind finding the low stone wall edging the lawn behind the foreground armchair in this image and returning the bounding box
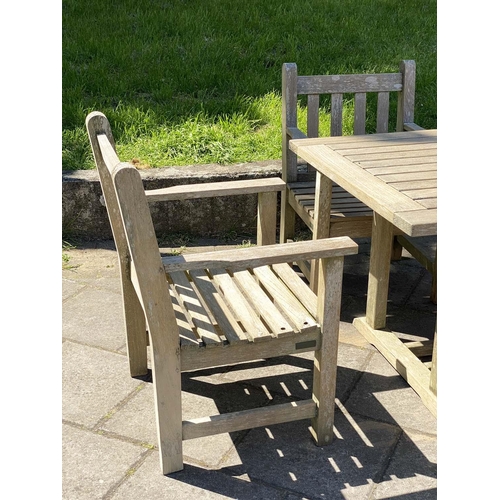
[62,160,281,240]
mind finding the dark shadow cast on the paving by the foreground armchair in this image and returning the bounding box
[136,355,437,499]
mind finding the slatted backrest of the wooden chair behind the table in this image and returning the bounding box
[281,60,415,182]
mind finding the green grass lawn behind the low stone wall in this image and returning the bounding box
[62,0,437,170]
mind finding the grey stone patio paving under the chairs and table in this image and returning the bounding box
[62,236,437,500]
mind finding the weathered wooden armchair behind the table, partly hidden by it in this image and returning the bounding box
[280,61,421,289]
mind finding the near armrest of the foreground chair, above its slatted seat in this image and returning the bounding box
[162,236,358,272]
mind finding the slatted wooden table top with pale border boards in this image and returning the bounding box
[290,130,437,236]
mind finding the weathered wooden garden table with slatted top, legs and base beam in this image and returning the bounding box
[290,130,437,415]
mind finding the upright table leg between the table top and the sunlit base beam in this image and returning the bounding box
[366,212,393,329]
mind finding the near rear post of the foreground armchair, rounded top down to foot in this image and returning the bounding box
[112,164,183,474]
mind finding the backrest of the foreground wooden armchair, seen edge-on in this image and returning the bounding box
[86,112,178,352]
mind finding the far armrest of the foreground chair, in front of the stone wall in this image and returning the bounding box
[146,177,286,202]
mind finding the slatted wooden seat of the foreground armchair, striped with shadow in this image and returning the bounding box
[165,263,321,371]
